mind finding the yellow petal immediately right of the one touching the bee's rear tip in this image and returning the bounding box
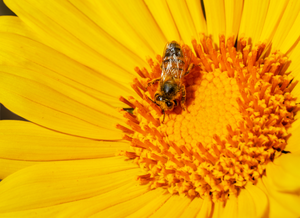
[167,0,199,46]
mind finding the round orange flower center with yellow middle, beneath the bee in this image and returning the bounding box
[117,36,300,201]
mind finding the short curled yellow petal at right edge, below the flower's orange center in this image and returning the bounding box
[266,161,300,193]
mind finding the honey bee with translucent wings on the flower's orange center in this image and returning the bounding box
[147,41,193,119]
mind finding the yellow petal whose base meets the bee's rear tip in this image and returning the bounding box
[145,0,181,43]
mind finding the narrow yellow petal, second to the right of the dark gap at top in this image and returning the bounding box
[224,0,244,41]
